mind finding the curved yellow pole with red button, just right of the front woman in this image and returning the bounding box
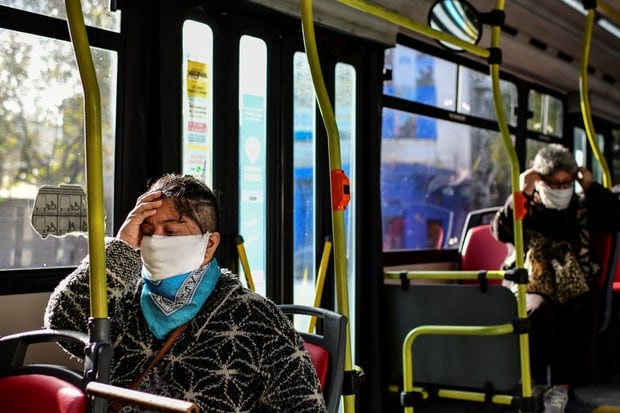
[301,0,355,413]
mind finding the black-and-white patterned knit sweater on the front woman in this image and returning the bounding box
[45,239,326,413]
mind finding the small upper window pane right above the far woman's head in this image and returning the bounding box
[527,90,564,137]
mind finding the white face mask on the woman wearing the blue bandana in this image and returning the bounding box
[140,232,209,281]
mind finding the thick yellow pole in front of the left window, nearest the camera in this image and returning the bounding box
[65,0,108,319]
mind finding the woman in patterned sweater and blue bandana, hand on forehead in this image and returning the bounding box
[45,175,326,413]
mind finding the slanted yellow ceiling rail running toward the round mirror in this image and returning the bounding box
[338,0,489,58]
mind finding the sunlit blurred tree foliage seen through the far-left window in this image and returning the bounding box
[0,0,115,194]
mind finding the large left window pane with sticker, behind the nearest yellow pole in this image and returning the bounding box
[0,29,117,268]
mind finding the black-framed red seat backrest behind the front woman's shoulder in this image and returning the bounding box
[278,304,347,413]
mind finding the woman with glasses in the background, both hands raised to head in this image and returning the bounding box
[492,144,620,413]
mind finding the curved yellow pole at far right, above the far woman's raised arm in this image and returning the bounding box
[579,9,611,188]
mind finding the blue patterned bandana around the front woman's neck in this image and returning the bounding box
[140,258,220,340]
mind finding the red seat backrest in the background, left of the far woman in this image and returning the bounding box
[460,224,508,271]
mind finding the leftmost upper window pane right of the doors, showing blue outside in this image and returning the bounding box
[383,45,457,111]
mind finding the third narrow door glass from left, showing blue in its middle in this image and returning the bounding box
[292,52,317,305]
